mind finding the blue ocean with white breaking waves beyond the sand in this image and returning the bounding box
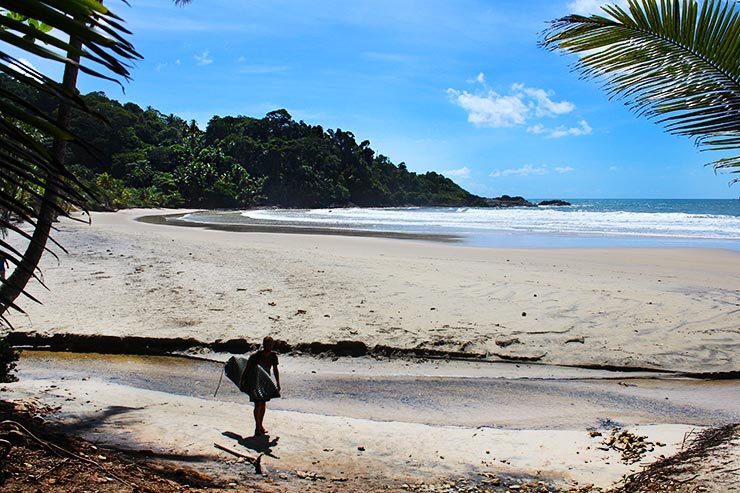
[182,199,740,251]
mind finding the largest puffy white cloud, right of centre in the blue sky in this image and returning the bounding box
[447,72,590,134]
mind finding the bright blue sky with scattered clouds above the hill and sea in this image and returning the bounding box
[17,0,740,199]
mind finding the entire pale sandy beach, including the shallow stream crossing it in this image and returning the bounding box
[4,210,740,492]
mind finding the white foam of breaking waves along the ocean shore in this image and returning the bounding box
[242,208,740,241]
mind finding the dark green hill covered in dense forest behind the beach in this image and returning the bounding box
[0,78,484,208]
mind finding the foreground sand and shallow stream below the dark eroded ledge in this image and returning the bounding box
[4,352,740,491]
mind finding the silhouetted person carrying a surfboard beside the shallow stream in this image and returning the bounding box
[245,336,280,436]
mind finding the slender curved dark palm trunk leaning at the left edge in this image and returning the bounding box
[0,33,82,316]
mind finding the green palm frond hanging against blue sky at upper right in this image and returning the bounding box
[541,0,740,182]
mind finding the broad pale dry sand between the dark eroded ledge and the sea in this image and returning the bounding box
[11,210,740,372]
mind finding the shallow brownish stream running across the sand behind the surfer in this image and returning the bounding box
[18,351,740,429]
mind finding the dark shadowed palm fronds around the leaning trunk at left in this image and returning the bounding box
[0,0,140,319]
